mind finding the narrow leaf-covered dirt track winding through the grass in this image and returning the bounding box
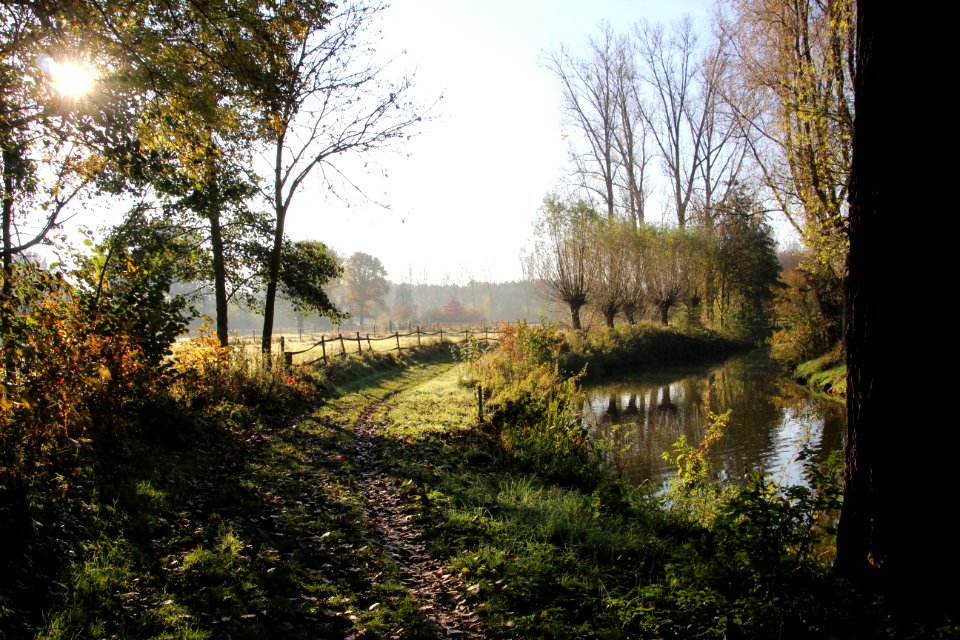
[355,398,487,638]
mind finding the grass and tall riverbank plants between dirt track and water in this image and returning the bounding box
[366,327,951,638]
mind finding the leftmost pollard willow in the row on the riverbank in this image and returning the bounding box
[525,196,597,329]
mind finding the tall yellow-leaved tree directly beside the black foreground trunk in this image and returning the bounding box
[718,0,856,342]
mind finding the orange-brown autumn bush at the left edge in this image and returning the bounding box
[0,266,178,519]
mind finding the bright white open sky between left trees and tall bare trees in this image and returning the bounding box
[287,0,708,284]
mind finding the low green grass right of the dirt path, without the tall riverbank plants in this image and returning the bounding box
[368,362,872,638]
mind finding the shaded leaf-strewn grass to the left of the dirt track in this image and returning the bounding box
[7,347,451,639]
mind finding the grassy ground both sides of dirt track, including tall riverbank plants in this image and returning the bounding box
[0,327,950,639]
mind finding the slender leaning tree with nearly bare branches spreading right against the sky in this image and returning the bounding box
[251,0,422,354]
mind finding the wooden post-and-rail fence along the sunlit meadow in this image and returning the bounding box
[272,327,500,368]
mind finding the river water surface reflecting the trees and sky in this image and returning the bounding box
[584,352,844,486]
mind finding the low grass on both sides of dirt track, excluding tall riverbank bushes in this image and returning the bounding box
[7,336,946,639]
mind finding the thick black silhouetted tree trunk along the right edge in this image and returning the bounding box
[834,0,960,616]
